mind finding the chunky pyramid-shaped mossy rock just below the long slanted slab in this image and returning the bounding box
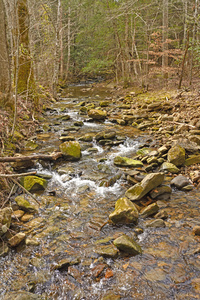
[109,197,138,224]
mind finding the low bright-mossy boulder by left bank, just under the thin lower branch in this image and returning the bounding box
[21,176,47,192]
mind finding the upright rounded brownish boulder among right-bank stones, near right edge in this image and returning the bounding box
[167,145,185,167]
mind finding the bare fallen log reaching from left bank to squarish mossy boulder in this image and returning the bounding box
[0,152,62,162]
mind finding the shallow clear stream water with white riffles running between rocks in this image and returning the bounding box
[0,86,200,300]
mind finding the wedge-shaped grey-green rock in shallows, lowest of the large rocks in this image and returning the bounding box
[113,234,142,255]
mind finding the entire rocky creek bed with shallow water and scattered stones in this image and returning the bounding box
[0,86,200,300]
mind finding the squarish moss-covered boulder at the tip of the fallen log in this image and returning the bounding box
[60,141,81,161]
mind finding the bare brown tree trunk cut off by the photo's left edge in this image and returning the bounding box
[0,0,11,107]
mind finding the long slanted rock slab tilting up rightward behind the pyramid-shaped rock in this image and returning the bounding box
[125,173,164,201]
